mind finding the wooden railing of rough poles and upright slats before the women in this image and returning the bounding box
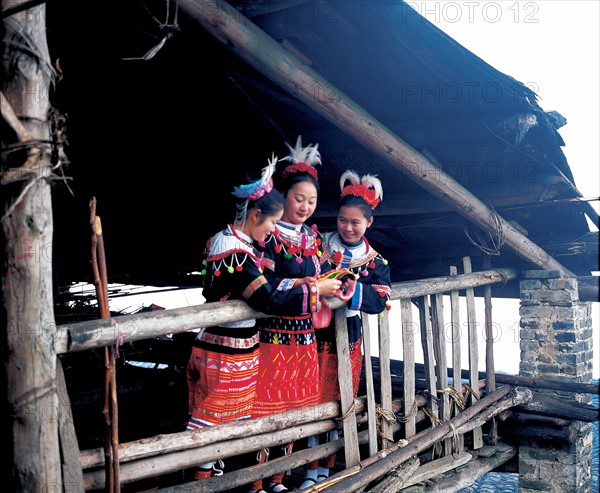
[56,258,527,492]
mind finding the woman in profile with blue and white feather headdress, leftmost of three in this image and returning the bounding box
[187,156,324,479]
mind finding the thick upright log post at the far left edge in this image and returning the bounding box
[0,0,61,493]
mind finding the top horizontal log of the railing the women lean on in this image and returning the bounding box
[55,269,517,354]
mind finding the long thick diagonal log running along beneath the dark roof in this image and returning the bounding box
[180,0,574,276]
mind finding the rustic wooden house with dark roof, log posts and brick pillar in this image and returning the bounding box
[0,0,599,493]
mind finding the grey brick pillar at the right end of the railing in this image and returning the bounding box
[519,270,593,493]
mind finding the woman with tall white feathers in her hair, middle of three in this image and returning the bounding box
[251,137,341,493]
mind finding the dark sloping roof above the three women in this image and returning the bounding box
[47,1,598,298]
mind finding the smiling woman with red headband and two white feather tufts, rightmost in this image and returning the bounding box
[300,170,391,489]
